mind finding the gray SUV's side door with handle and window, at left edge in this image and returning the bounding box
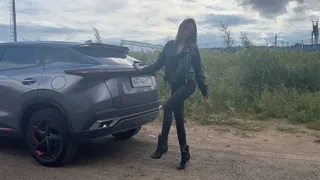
[0,46,43,130]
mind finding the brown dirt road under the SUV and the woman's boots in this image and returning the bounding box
[0,123,320,180]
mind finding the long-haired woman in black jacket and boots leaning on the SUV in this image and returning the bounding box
[134,18,209,170]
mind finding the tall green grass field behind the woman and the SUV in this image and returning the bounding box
[131,49,320,130]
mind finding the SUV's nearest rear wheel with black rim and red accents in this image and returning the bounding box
[26,108,78,167]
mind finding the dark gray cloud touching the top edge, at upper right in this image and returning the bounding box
[238,0,304,18]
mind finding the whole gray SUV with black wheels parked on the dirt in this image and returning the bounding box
[0,42,160,166]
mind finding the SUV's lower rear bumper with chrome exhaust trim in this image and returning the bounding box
[73,102,160,140]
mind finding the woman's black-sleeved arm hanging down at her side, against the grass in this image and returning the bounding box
[192,47,210,97]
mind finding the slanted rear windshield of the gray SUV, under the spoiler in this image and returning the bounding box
[74,46,137,66]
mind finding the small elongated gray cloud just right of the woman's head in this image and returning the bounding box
[199,14,256,28]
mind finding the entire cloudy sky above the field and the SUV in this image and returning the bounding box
[0,0,320,47]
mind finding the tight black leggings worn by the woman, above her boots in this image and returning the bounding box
[161,81,197,146]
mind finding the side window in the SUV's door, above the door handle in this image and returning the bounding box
[0,47,41,70]
